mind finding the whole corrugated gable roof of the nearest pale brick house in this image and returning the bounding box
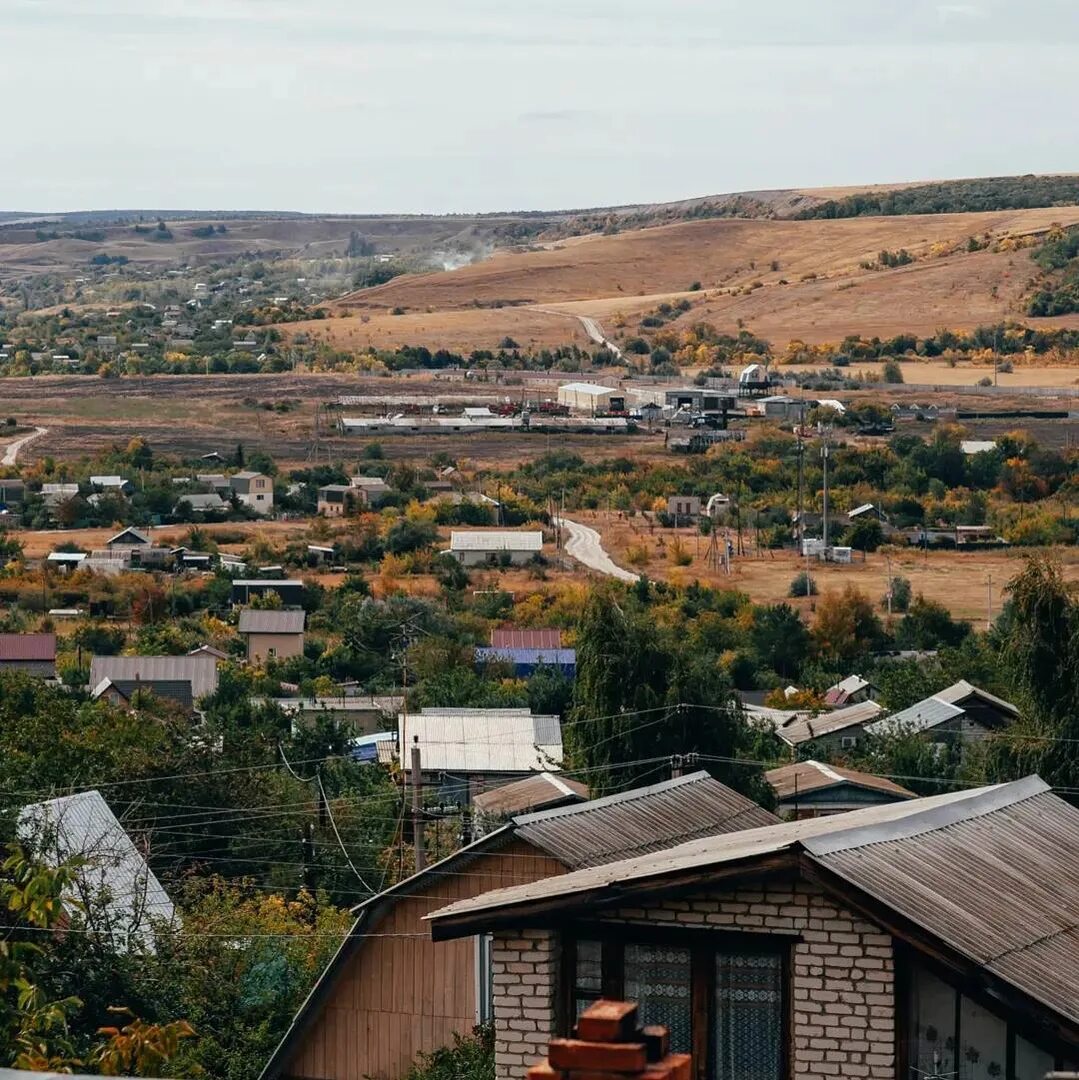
[428,777,1079,1041]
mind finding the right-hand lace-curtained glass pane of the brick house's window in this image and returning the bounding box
[715,953,783,1080]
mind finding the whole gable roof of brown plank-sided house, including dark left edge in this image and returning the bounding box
[260,772,777,1080]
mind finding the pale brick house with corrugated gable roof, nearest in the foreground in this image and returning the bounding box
[429,777,1079,1080]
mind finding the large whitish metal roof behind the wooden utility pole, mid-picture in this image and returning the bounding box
[397,708,562,773]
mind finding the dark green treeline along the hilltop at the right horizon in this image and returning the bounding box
[796,175,1079,220]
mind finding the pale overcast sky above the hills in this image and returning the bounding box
[0,0,1079,214]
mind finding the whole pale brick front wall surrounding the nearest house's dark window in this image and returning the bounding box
[495,885,895,1080]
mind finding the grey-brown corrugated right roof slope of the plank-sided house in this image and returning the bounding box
[515,772,779,869]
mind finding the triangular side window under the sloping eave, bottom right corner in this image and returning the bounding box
[905,959,1067,1080]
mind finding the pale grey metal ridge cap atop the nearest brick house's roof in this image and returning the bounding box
[800,775,1051,855]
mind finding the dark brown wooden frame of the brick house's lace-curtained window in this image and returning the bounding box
[557,922,801,1080]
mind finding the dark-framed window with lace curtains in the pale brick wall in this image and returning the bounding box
[564,928,793,1080]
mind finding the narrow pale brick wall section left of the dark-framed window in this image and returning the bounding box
[491,930,558,1080]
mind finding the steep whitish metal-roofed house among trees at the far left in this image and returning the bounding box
[15,791,176,950]
